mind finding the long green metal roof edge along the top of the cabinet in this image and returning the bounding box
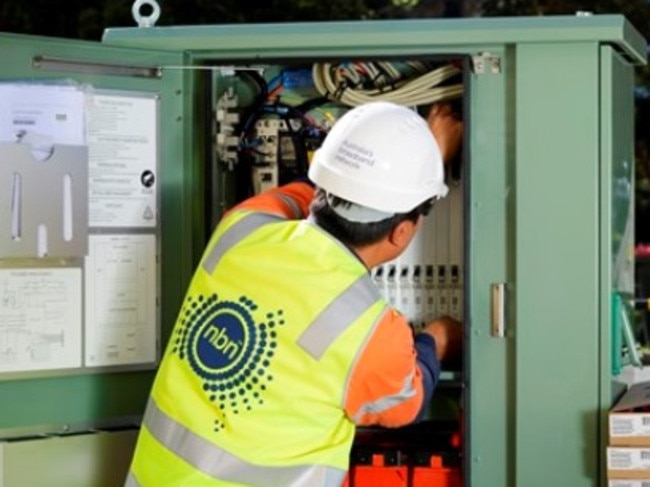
[103,15,646,65]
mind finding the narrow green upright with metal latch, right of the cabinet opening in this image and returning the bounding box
[465,46,515,487]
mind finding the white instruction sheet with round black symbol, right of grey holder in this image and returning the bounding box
[87,92,158,228]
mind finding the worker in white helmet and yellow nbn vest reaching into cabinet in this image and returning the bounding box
[126,101,462,487]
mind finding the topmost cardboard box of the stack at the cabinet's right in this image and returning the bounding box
[609,382,650,446]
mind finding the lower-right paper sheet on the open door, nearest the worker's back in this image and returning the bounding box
[85,235,158,367]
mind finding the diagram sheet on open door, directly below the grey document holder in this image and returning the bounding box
[0,268,81,373]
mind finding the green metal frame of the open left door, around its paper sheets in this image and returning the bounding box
[0,34,197,436]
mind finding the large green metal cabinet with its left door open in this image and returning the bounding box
[0,15,646,487]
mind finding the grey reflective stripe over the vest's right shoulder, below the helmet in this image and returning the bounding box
[297,274,385,359]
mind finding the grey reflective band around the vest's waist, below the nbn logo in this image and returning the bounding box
[140,398,346,487]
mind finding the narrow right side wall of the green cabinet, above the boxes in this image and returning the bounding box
[599,46,641,485]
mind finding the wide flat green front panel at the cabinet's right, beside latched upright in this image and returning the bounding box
[514,42,600,487]
